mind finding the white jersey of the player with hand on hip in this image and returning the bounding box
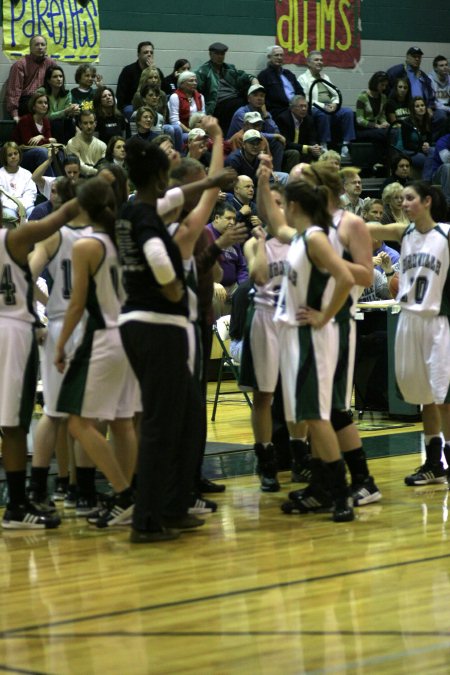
[274,225,330,326]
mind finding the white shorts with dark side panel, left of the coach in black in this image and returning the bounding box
[57,328,140,421]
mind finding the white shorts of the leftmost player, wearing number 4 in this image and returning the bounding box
[0,319,38,431]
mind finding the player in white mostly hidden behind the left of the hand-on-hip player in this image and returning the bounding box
[239,188,310,492]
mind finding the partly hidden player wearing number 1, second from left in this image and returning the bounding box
[29,178,92,508]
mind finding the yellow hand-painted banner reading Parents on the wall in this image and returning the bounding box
[3,0,100,63]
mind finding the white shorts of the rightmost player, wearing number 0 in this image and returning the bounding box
[395,310,450,405]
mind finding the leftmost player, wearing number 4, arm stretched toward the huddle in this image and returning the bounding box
[0,195,78,529]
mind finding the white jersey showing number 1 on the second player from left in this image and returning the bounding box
[47,225,92,320]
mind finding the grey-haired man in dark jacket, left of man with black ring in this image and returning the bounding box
[258,45,305,119]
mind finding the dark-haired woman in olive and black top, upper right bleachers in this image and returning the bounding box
[356,70,389,152]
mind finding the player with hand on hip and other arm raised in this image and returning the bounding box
[258,164,354,522]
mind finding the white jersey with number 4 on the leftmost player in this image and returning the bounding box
[0,229,37,323]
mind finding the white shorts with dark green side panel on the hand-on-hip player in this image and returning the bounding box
[279,322,339,422]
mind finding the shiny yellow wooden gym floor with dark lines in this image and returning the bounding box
[0,382,450,675]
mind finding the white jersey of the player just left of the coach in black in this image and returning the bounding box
[82,232,125,330]
